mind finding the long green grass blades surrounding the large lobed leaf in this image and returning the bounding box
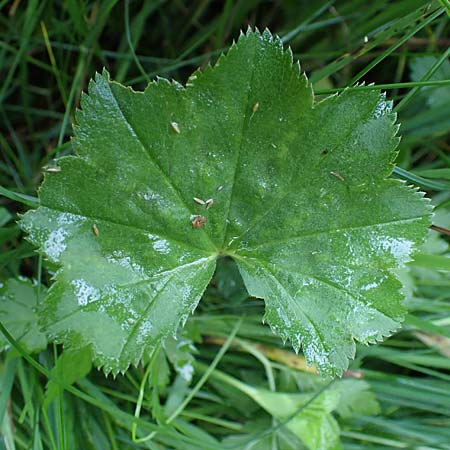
[0,0,450,450]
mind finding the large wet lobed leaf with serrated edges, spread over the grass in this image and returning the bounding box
[22,31,429,375]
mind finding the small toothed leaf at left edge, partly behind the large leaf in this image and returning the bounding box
[0,278,47,353]
